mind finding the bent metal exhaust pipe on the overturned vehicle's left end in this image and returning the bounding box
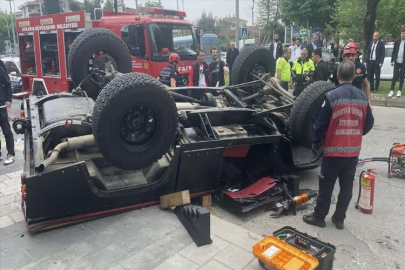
[37,134,97,172]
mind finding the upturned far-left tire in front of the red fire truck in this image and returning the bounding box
[68,28,132,100]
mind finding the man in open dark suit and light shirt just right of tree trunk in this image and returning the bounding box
[366,32,385,92]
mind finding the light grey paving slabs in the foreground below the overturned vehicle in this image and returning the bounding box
[0,200,270,270]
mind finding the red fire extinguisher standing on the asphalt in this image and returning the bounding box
[355,169,377,214]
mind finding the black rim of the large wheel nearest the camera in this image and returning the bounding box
[119,106,161,152]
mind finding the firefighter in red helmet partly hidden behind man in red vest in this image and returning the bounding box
[329,42,371,104]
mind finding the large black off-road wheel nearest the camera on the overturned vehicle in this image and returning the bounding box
[93,73,177,170]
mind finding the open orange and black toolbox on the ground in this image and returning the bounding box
[253,226,336,270]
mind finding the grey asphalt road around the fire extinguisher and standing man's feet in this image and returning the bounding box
[213,107,405,270]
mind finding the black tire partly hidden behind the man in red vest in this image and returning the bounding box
[289,81,335,148]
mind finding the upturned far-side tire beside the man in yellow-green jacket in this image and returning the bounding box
[231,44,274,85]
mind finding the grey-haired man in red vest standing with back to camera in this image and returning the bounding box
[304,60,374,229]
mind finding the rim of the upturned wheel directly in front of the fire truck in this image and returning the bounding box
[88,51,117,87]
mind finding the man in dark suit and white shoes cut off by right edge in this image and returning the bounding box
[388,25,405,97]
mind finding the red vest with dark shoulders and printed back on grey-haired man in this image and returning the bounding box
[324,84,368,157]
